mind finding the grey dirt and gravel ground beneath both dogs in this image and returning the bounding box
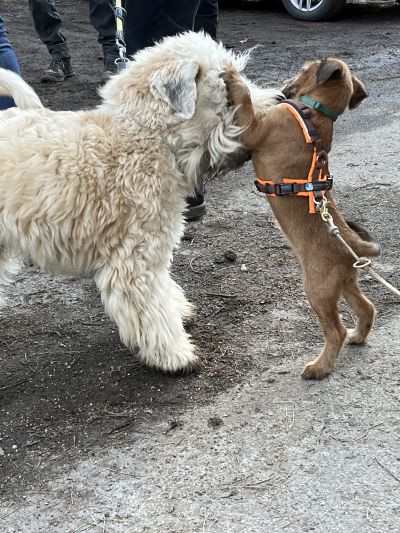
[0,0,400,533]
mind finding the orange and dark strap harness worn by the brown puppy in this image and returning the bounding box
[254,100,333,213]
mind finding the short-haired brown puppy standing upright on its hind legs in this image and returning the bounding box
[224,58,379,379]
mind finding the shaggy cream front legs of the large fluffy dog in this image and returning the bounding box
[96,263,198,372]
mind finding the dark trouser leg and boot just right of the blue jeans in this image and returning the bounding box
[29,0,74,82]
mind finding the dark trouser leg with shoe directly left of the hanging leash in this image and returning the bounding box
[89,0,118,81]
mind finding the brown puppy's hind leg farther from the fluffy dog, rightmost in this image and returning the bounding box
[343,278,376,344]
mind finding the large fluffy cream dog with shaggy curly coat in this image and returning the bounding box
[0,32,274,372]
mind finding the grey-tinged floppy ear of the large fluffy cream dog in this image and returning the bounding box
[149,61,199,119]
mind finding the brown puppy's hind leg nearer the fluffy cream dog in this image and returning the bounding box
[301,275,347,379]
